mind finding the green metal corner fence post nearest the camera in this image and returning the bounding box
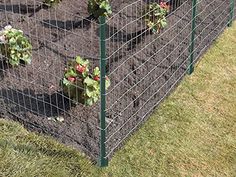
[98,16,108,167]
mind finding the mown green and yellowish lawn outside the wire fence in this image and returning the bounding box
[0,24,236,177]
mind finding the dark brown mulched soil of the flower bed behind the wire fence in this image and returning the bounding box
[0,0,228,159]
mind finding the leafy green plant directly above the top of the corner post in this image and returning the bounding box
[88,0,112,18]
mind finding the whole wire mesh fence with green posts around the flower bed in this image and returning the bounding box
[0,0,236,165]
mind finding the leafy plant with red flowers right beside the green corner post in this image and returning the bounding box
[61,56,110,106]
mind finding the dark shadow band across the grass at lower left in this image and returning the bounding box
[0,137,87,176]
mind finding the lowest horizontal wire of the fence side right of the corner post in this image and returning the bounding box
[106,13,231,158]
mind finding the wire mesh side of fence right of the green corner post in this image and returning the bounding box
[103,0,234,158]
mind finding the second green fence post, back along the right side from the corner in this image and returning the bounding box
[188,0,197,74]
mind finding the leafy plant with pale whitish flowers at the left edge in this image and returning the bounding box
[0,25,32,66]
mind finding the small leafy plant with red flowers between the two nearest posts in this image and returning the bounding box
[143,2,169,33]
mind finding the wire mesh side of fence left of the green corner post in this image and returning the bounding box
[0,0,100,166]
